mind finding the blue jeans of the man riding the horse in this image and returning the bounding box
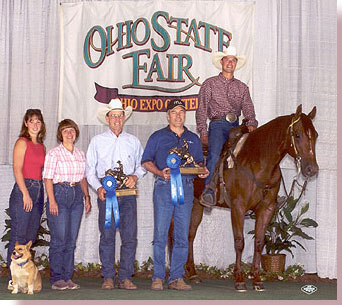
[204,120,239,185]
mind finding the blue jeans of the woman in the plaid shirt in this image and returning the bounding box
[46,184,84,284]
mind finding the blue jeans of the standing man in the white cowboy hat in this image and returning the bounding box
[97,196,137,282]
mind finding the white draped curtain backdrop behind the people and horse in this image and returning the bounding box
[0,0,337,278]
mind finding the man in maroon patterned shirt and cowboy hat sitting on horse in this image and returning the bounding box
[196,46,258,207]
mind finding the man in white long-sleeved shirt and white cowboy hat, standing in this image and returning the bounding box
[86,99,146,290]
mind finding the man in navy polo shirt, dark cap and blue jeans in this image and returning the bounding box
[141,100,209,290]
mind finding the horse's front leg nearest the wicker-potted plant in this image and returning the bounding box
[251,205,275,291]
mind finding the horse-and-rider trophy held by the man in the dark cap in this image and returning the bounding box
[169,139,206,175]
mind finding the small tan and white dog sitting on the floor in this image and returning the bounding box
[10,240,42,294]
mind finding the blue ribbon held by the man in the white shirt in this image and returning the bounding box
[102,176,120,229]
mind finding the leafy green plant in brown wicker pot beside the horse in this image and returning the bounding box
[248,196,318,273]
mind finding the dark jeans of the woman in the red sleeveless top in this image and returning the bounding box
[7,179,44,279]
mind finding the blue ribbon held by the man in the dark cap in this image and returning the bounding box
[166,154,184,205]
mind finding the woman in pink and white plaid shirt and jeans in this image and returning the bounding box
[43,119,91,290]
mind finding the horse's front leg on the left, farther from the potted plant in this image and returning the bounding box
[231,201,247,292]
